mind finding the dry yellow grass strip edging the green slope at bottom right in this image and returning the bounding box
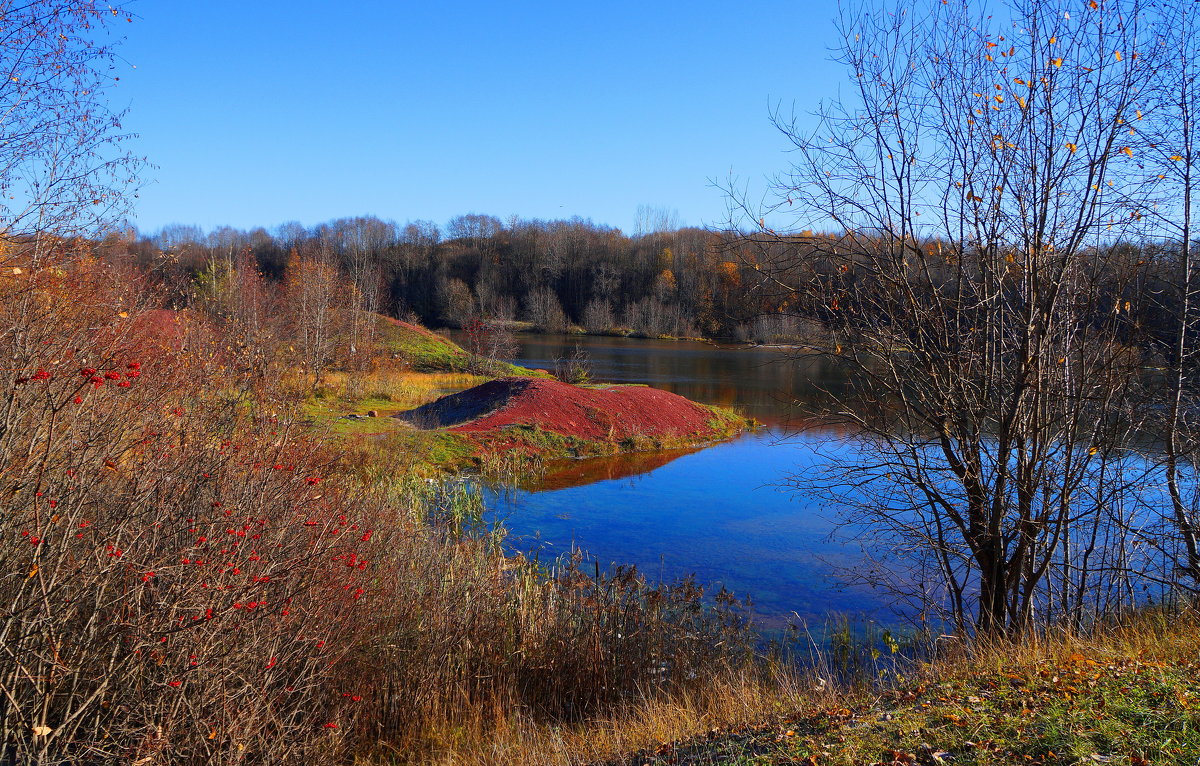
[391,609,1200,766]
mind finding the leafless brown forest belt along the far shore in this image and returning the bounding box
[96,214,1200,362]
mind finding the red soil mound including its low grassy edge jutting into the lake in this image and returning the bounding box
[396,377,746,454]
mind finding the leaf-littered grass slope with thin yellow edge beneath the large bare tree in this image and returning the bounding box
[590,610,1200,766]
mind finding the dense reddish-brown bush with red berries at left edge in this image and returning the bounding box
[0,250,374,762]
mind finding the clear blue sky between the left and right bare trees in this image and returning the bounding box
[112,0,845,237]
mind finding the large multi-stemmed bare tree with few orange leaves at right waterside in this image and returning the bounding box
[737,0,1154,635]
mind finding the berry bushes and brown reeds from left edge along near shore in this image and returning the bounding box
[0,243,745,764]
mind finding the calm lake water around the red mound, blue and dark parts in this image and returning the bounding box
[468,335,895,624]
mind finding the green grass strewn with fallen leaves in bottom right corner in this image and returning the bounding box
[634,628,1200,766]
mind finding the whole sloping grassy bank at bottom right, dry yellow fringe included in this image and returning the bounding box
[393,609,1200,766]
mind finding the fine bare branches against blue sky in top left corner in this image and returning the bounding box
[0,0,142,250]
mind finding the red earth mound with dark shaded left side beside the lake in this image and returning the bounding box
[397,378,714,442]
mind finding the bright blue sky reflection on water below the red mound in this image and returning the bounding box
[488,431,892,626]
